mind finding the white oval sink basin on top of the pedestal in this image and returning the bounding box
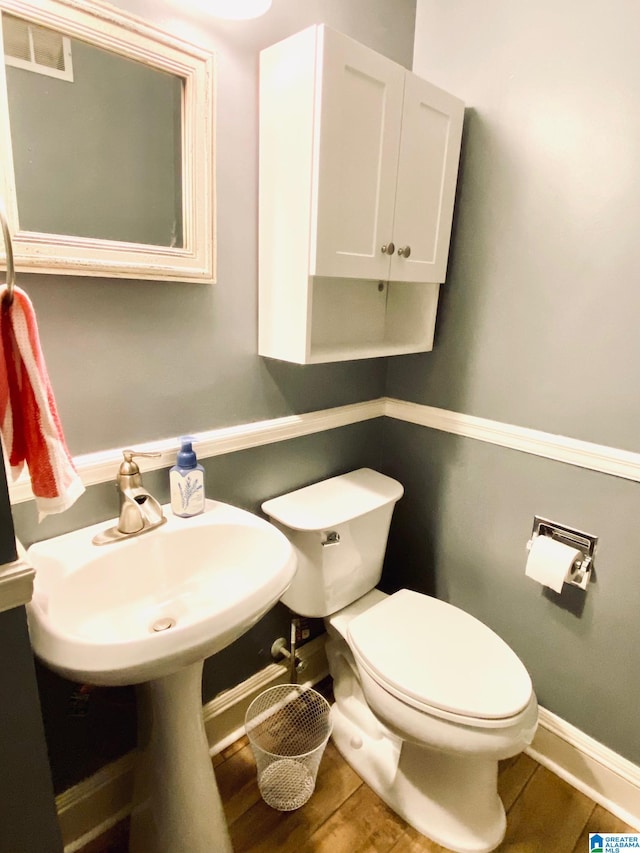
[27,501,296,685]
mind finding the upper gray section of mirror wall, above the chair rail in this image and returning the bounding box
[6,0,415,454]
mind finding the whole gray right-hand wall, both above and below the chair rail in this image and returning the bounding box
[378,0,640,763]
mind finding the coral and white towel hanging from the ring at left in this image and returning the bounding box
[0,287,84,519]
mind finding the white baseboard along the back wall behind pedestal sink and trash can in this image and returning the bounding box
[56,634,329,853]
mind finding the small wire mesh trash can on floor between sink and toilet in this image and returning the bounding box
[245,684,331,812]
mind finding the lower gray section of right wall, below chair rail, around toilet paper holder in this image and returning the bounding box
[383,421,640,763]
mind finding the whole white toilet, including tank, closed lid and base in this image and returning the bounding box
[262,468,538,853]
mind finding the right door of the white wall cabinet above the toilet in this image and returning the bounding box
[390,72,464,283]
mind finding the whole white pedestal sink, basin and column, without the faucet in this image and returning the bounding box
[27,501,296,853]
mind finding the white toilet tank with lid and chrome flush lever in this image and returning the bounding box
[262,468,404,616]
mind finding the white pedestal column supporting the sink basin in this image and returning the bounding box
[129,661,232,853]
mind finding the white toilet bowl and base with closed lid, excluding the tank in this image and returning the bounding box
[325,590,538,853]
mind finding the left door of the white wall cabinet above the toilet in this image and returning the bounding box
[310,27,405,279]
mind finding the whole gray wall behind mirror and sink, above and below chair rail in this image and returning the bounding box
[7,0,415,791]
